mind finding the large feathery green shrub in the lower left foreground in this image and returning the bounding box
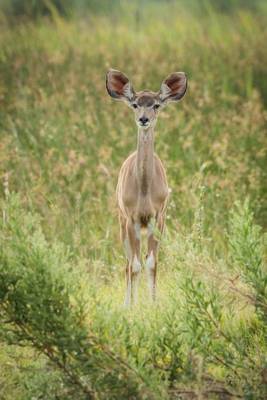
[0,196,155,399]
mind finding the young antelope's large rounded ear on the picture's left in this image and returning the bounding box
[106,69,135,102]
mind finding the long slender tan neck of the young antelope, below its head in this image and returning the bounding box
[136,127,154,195]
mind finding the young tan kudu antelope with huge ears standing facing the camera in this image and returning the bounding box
[106,69,187,306]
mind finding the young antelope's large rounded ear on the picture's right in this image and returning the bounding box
[159,72,187,103]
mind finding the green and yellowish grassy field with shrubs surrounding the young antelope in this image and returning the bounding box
[0,1,267,400]
